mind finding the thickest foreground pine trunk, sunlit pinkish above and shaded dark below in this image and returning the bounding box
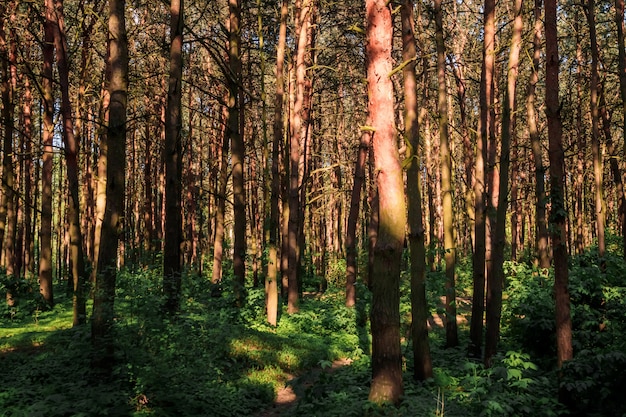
[365,0,406,403]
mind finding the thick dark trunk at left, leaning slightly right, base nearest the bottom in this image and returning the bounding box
[91,0,128,375]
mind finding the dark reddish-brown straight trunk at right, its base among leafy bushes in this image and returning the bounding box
[544,0,573,368]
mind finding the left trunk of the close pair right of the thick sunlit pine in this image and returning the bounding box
[469,0,495,358]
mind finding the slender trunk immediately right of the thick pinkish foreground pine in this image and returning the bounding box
[402,0,432,381]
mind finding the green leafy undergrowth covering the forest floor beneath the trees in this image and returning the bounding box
[0,239,626,417]
